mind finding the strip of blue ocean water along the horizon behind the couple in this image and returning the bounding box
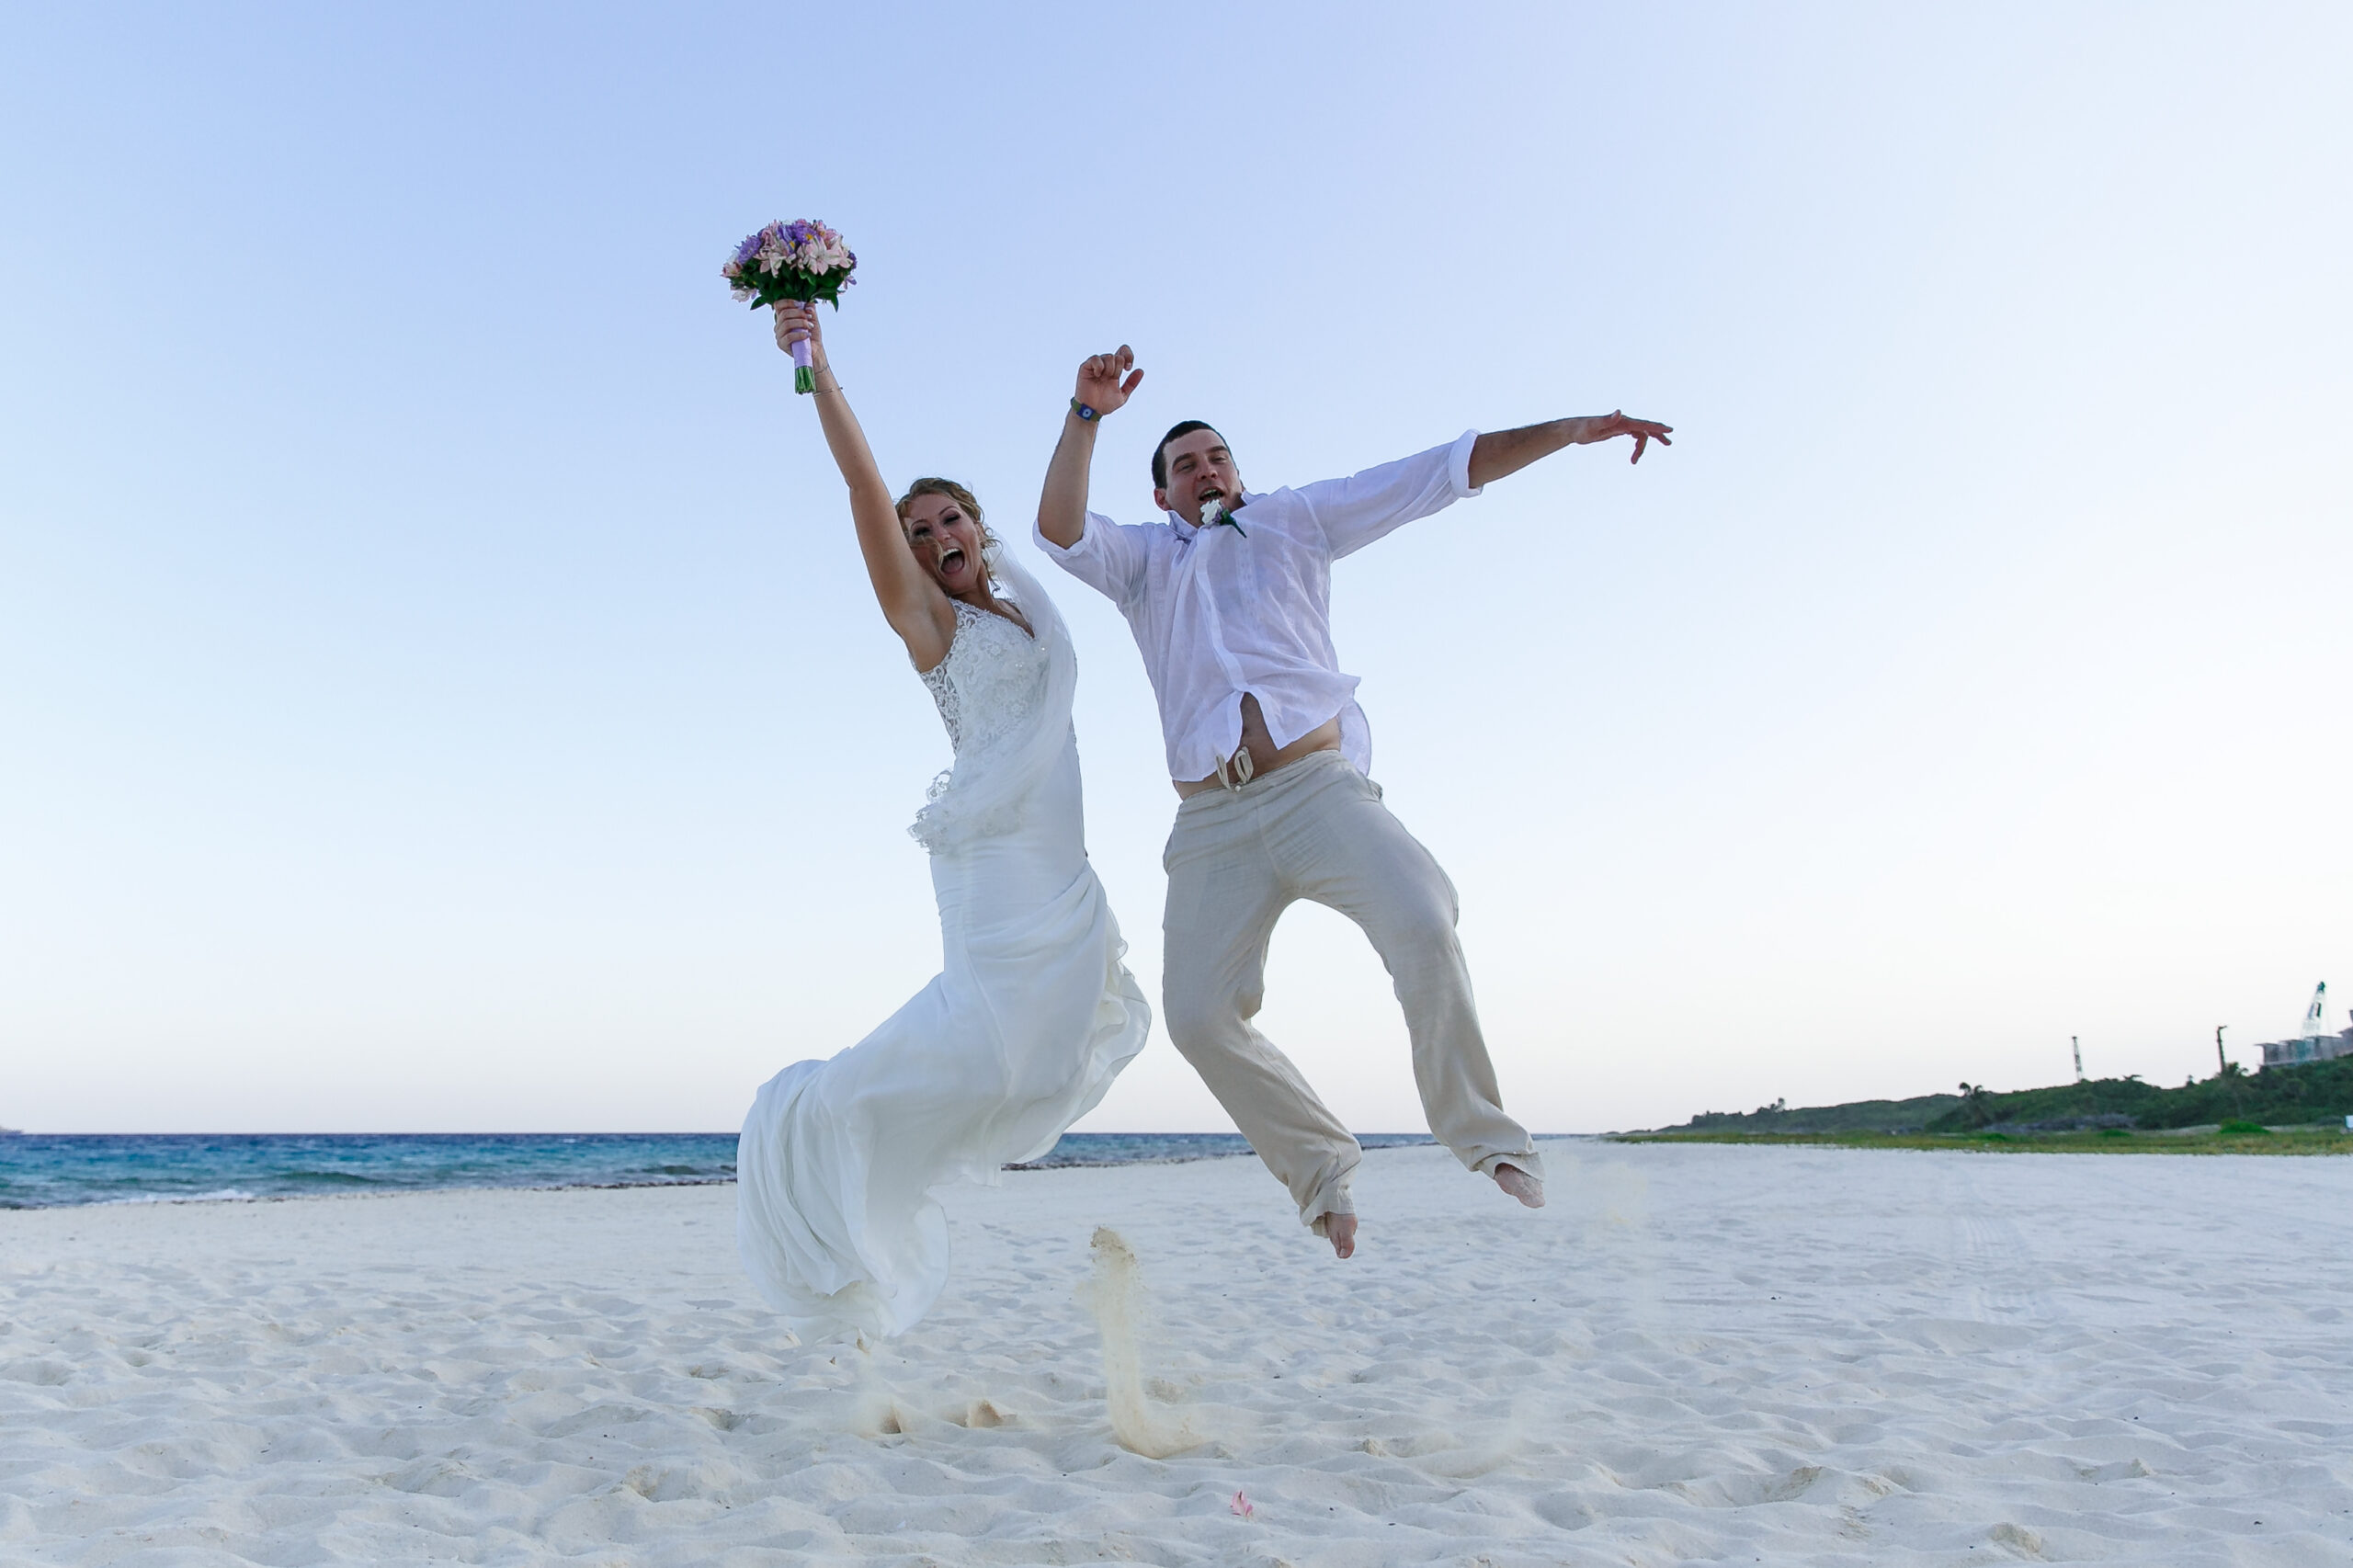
[0,1132,1430,1208]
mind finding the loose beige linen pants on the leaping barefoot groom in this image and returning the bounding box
[1163,751,1543,1232]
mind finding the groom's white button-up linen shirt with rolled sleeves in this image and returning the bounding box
[1035,431,1478,779]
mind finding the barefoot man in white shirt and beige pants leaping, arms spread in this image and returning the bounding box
[1038,347,1673,1257]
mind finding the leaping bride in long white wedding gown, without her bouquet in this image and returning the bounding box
[736,303,1151,1335]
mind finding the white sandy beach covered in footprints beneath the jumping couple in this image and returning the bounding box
[0,1144,2353,1568]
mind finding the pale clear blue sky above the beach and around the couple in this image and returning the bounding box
[0,5,2353,1131]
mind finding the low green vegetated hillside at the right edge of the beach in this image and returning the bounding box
[1631,1057,2353,1153]
